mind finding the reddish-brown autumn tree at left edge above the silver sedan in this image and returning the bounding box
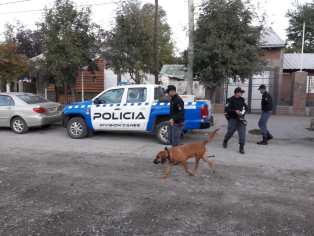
[0,43,28,92]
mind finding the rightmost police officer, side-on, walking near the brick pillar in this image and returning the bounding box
[257,84,273,145]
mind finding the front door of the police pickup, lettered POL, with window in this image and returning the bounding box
[91,88,125,130]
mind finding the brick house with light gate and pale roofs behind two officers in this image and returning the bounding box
[214,28,314,115]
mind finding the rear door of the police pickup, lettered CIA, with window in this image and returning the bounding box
[121,87,151,131]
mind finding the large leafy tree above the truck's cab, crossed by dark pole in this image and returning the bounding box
[106,0,173,83]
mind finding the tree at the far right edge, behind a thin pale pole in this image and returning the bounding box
[287,3,314,53]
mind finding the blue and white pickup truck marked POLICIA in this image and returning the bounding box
[63,85,212,144]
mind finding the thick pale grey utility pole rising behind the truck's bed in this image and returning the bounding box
[186,0,194,94]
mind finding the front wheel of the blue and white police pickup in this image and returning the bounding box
[67,117,88,139]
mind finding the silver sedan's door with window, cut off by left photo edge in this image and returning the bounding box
[0,95,14,127]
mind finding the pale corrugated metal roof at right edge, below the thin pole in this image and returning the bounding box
[283,53,314,70]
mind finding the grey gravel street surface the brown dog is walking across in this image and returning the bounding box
[0,121,314,236]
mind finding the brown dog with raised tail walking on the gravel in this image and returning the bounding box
[154,129,219,179]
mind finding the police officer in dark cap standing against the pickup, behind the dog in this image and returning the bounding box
[167,85,184,146]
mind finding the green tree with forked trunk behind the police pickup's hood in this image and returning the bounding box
[41,0,99,102]
